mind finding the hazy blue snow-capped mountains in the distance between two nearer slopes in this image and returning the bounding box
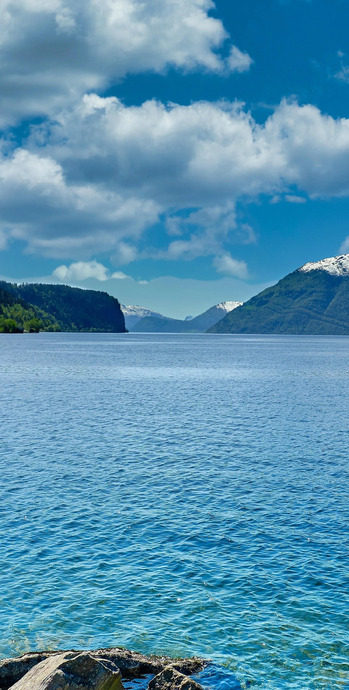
[131,302,241,333]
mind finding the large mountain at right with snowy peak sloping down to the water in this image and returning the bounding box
[209,254,349,335]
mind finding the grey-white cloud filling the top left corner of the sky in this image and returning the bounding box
[0,0,237,124]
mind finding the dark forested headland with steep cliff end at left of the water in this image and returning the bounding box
[0,281,126,333]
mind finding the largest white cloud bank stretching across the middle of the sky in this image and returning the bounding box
[0,94,349,270]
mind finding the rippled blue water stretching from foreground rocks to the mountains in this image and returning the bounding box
[0,333,349,690]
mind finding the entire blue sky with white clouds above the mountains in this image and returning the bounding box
[0,0,349,318]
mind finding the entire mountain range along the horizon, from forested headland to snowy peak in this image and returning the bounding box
[0,254,349,335]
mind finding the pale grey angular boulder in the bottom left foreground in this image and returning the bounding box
[8,652,123,690]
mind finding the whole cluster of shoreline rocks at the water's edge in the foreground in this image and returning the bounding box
[0,647,208,690]
